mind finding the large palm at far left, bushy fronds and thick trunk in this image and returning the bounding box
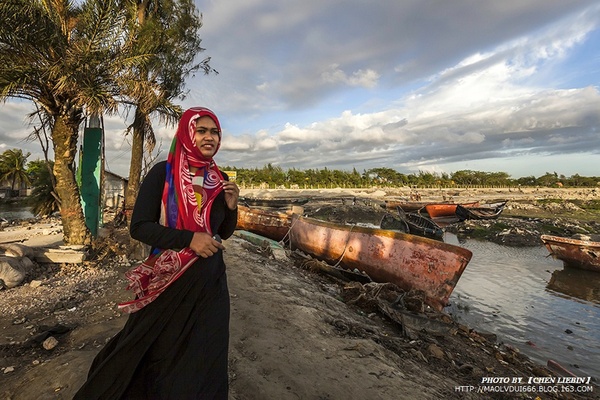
[0,0,143,244]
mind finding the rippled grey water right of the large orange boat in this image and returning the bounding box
[444,233,600,378]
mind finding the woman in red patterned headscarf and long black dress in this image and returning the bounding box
[75,107,239,400]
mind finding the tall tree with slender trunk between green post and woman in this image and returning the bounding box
[124,0,216,210]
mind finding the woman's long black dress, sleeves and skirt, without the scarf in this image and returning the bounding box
[74,162,237,400]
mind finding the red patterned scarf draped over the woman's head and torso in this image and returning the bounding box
[118,107,223,313]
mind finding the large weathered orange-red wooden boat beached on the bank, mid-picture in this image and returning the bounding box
[290,214,472,311]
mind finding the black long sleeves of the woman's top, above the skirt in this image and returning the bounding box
[129,161,237,249]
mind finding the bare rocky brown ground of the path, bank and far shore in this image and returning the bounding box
[0,190,600,400]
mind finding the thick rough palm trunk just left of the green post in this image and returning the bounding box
[52,117,92,245]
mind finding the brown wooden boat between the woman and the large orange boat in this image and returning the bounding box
[236,205,292,242]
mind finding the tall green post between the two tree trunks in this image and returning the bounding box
[79,118,102,237]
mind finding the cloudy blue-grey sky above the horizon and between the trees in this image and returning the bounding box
[0,0,600,178]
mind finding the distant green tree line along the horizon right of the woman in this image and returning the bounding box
[222,164,600,189]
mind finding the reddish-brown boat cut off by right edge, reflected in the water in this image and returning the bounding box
[541,235,600,272]
